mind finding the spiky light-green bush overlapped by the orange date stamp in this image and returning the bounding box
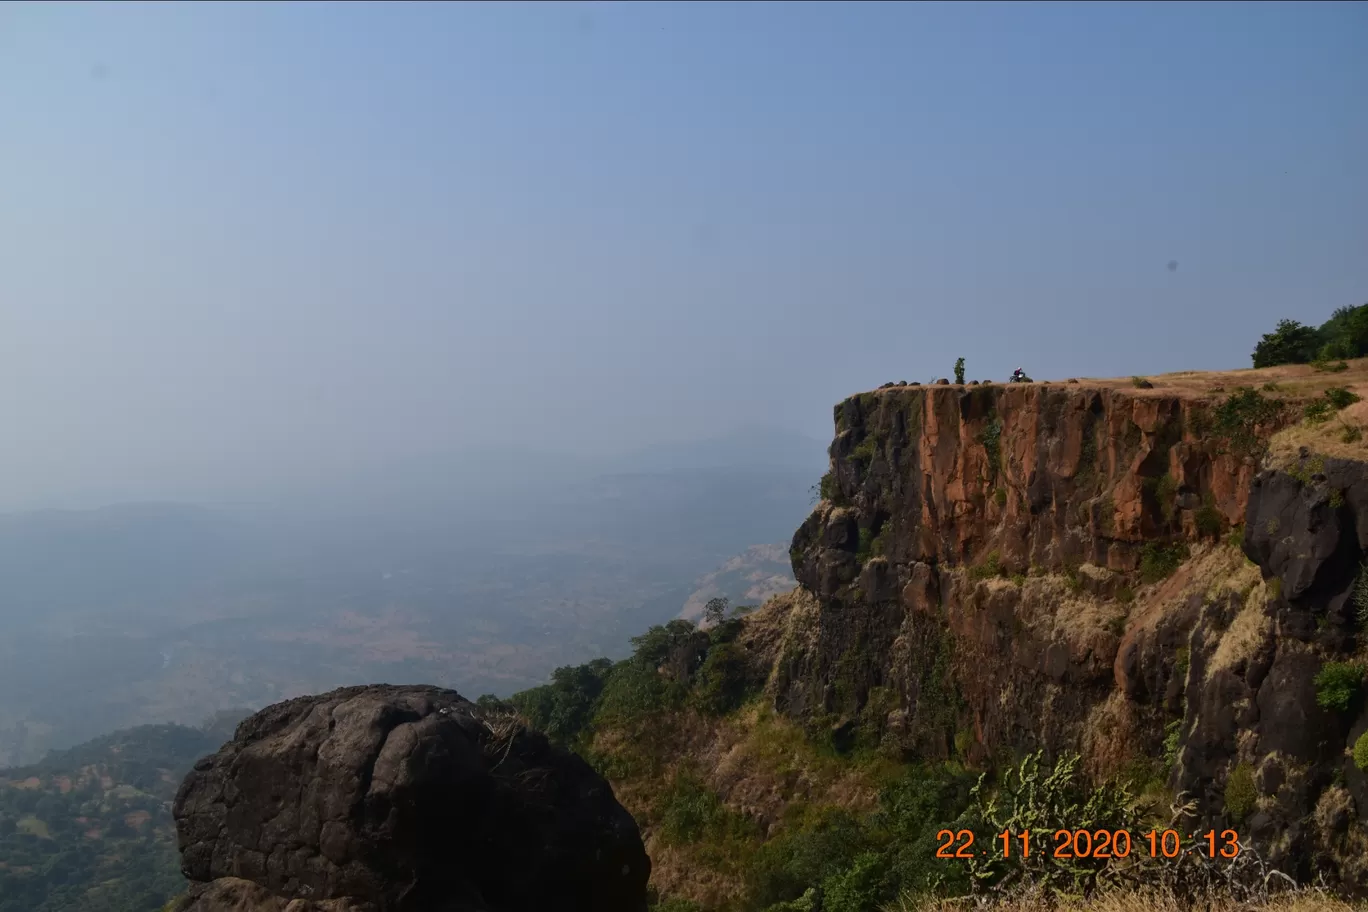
[967,752,1141,893]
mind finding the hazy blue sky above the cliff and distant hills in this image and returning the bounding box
[0,3,1368,509]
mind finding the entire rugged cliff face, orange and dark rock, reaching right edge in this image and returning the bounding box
[770,384,1368,887]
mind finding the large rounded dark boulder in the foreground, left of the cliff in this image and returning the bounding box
[174,685,650,912]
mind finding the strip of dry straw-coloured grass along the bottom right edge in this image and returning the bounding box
[886,890,1368,912]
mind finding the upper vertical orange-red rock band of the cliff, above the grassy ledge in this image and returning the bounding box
[793,384,1256,595]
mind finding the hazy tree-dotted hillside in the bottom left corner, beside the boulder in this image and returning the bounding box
[0,712,245,912]
